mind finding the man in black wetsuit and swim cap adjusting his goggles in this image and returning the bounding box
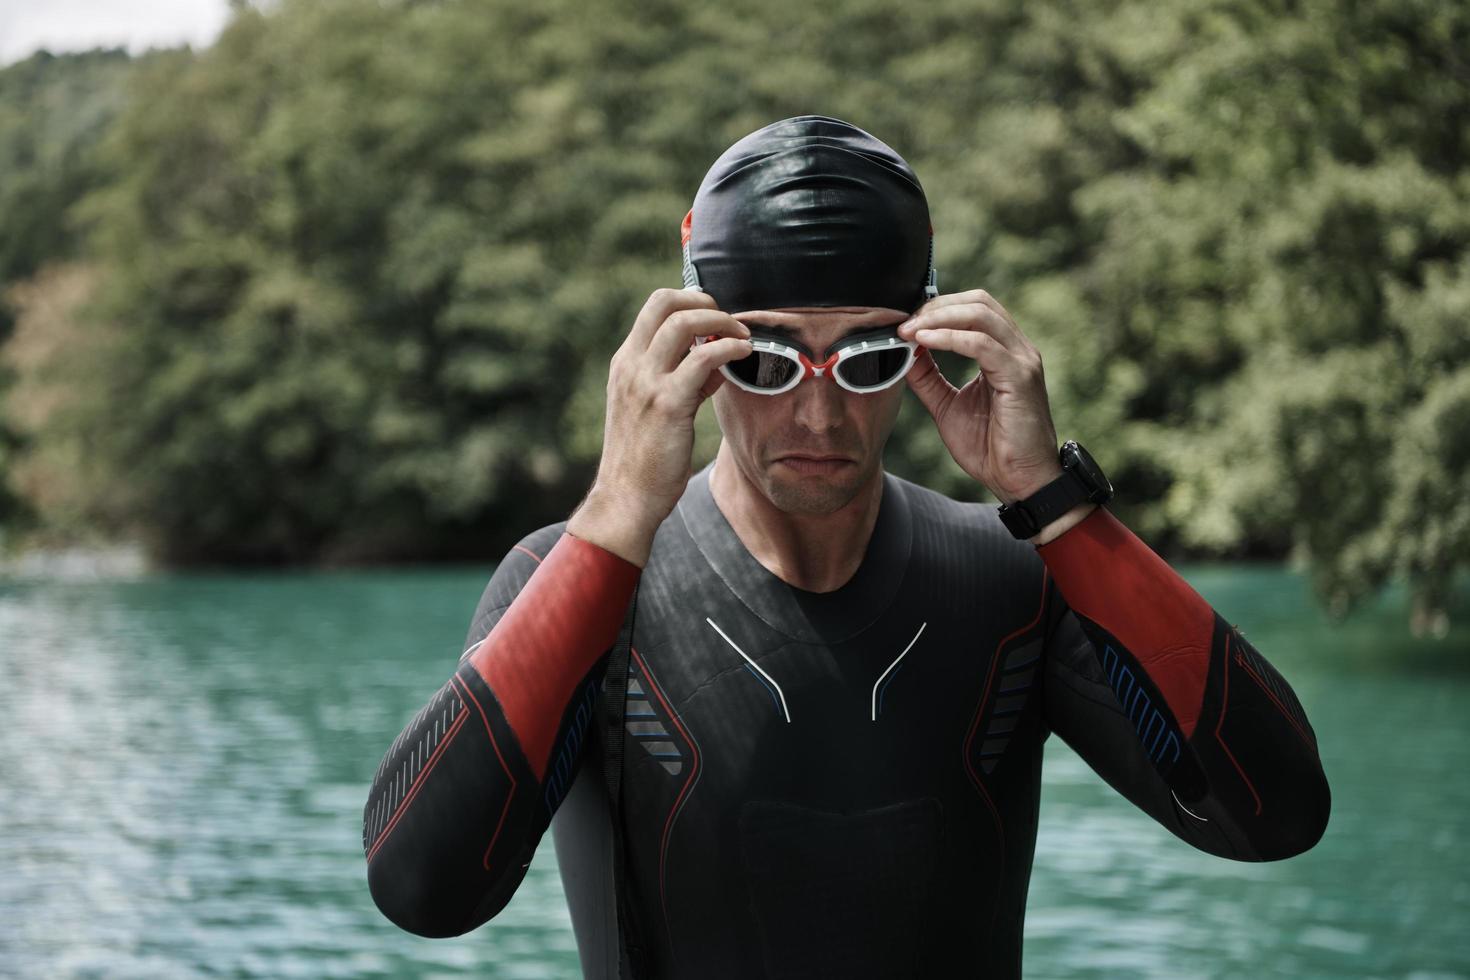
[363,116,1329,979]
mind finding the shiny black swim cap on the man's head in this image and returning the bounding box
[682,116,938,313]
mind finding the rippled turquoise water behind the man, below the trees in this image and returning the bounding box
[0,566,1470,980]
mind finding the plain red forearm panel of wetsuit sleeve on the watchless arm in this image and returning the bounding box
[469,533,642,782]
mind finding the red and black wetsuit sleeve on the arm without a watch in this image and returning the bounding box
[363,525,639,936]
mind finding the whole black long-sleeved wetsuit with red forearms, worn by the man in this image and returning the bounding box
[363,467,1329,980]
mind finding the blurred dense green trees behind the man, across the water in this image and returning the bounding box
[0,0,1470,623]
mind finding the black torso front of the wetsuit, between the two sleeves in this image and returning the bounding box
[596,479,1044,979]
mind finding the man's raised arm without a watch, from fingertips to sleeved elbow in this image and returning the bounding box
[363,289,751,936]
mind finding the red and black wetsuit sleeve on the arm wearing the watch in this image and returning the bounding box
[1036,507,1332,861]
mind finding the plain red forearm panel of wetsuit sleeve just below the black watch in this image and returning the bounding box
[1036,507,1214,738]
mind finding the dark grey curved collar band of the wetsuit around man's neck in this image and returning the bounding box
[678,463,913,644]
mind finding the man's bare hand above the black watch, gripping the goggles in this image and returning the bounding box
[898,289,1061,504]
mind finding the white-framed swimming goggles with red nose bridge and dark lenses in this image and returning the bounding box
[694,329,919,395]
